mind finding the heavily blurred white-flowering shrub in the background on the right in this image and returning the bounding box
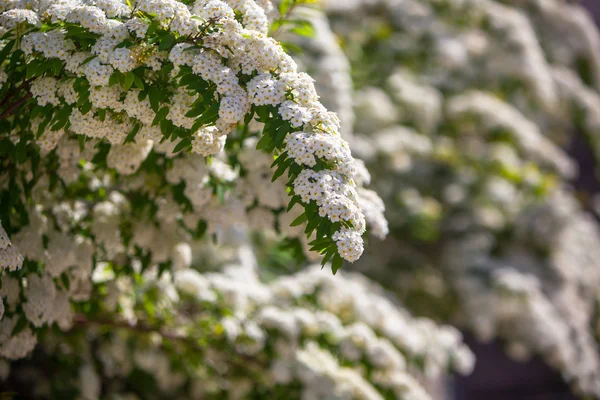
[290,0,600,397]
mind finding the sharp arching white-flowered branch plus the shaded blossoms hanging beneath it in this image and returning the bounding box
[0,0,394,376]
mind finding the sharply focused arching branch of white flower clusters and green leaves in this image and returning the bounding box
[0,0,365,272]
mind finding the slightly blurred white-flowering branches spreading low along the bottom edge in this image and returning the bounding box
[0,247,473,399]
